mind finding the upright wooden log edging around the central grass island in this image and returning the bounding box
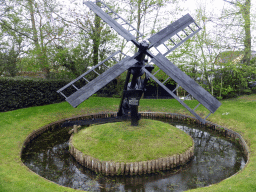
[69,135,194,176]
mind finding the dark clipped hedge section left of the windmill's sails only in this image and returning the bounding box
[0,78,68,112]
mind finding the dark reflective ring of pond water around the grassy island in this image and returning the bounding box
[22,120,246,192]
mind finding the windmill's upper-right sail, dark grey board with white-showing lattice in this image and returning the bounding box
[148,14,201,56]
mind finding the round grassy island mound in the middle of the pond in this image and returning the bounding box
[72,119,193,163]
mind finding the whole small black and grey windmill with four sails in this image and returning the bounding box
[57,1,221,126]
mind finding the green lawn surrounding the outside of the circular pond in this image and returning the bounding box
[0,95,256,192]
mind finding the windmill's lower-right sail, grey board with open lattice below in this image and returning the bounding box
[143,54,221,123]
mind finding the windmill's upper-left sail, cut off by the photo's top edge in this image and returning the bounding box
[84,1,143,46]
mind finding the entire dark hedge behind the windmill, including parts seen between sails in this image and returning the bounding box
[0,77,178,112]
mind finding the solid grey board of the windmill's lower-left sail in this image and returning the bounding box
[58,56,137,107]
